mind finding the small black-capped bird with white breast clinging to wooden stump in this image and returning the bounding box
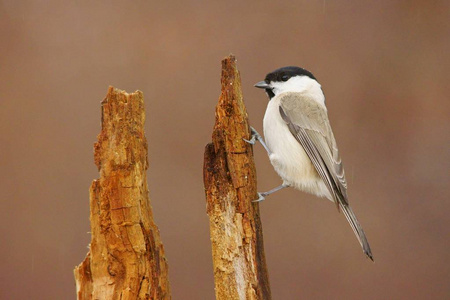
[247,66,373,261]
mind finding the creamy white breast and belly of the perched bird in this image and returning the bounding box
[263,96,331,198]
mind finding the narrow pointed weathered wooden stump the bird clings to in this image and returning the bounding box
[203,55,271,300]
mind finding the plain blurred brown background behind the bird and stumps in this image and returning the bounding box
[0,0,450,299]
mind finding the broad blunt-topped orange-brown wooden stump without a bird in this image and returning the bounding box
[74,87,171,300]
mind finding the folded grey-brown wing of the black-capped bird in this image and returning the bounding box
[279,93,348,204]
